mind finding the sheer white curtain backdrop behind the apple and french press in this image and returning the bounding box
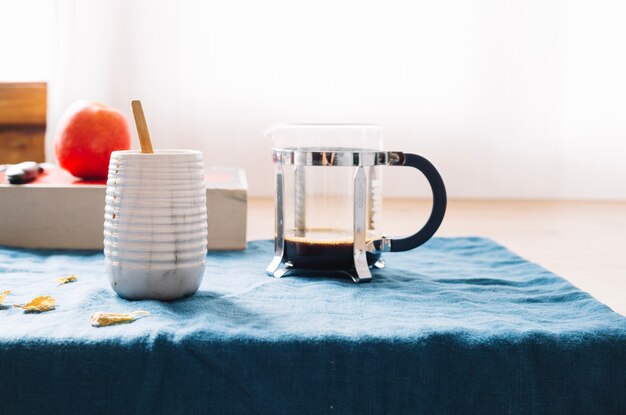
[1,0,626,199]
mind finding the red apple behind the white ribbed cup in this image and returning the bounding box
[54,100,130,180]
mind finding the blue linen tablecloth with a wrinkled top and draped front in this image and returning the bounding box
[0,238,626,415]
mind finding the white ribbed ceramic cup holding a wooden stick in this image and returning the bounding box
[104,150,207,300]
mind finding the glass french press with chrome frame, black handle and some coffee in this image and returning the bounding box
[266,125,447,282]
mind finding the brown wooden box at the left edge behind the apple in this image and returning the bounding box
[0,82,47,164]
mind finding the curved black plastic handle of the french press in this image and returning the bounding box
[390,153,448,252]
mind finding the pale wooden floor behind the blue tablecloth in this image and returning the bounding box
[248,198,626,316]
